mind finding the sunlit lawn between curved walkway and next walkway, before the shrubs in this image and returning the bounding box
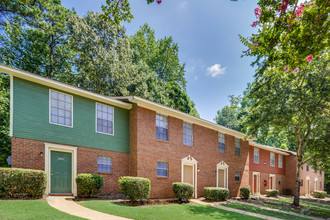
[79,200,259,220]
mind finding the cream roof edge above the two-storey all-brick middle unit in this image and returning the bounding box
[114,96,247,139]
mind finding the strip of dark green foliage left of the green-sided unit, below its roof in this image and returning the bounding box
[0,74,11,167]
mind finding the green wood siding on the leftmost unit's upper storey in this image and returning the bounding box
[13,77,129,153]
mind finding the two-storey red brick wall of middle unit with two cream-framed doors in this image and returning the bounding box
[131,107,249,198]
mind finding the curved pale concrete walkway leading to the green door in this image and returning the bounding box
[47,196,128,220]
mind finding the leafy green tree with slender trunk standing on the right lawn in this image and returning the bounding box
[246,54,330,206]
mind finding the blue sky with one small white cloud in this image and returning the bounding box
[62,0,257,121]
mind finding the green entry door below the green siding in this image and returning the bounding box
[50,151,72,193]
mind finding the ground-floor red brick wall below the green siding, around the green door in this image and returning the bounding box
[12,137,129,194]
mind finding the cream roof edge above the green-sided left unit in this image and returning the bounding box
[0,64,132,109]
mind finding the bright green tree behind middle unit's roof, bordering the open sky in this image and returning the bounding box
[129,24,199,117]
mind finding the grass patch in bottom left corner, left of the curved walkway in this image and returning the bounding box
[0,200,82,220]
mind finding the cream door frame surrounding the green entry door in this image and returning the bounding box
[45,143,77,196]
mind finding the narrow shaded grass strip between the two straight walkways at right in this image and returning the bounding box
[222,203,307,219]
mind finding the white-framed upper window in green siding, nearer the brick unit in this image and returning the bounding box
[96,103,114,135]
